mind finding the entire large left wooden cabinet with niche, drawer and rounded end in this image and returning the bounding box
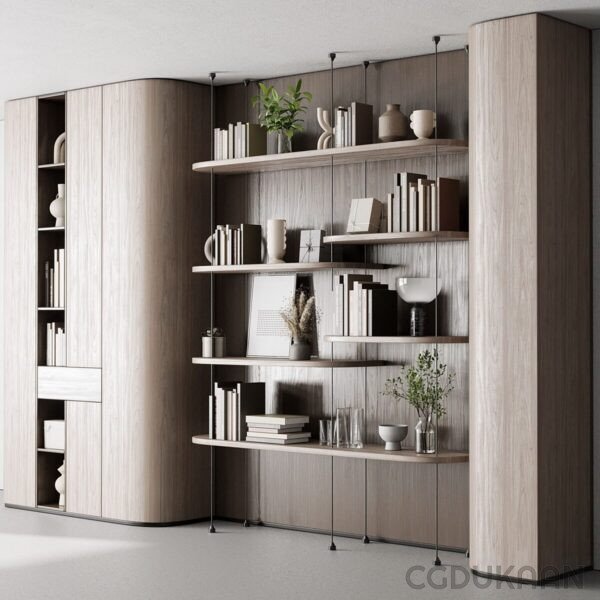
[5,80,208,523]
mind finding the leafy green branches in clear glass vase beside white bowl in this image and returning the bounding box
[383,349,456,454]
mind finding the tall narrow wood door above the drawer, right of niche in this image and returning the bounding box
[65,87,102,367]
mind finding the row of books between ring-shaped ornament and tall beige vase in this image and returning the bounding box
[213,223,262,265]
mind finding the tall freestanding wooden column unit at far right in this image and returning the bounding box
[469,15,591,580]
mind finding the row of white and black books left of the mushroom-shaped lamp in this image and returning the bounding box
[335,273,398,337]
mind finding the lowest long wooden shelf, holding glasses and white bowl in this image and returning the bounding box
[192,434,469,464]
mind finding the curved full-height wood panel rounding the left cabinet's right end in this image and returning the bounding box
[102,80,210,522]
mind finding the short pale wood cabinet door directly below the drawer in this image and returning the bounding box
[65,401,102,517]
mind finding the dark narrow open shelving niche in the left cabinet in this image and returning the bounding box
[35,93,66,512]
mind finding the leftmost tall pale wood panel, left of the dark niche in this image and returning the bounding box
[3,98,37,506]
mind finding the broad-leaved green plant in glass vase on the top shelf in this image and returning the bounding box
[252,79,312,154]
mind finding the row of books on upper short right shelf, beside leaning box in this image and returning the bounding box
[385,172,460,233]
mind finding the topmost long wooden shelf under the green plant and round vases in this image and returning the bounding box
[192,140,468,173]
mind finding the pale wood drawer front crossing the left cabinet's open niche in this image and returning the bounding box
[38,367,102,402]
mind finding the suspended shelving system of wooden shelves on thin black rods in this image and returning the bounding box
[192,37,469,565]
